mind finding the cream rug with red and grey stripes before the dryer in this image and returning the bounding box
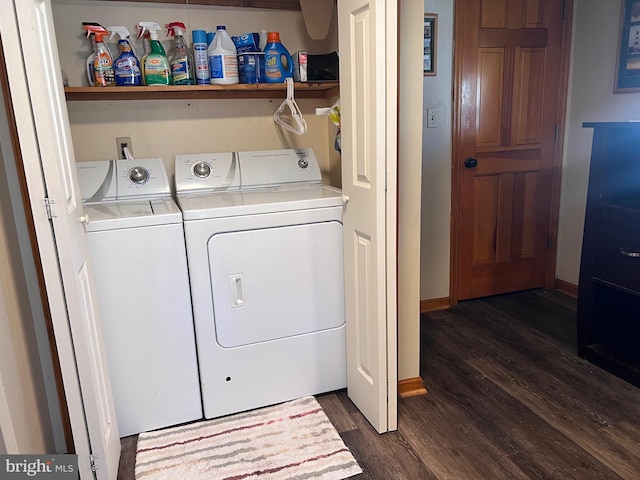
[135,397,362,480]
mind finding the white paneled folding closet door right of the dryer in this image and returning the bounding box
[338,0,397,433]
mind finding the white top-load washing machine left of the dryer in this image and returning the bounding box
[77,158,202,437]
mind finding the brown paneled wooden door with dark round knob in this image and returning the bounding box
[452,0,571,300]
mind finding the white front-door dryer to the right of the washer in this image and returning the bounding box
[175,149,346,418]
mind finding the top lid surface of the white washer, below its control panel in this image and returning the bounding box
[83,198,182,232]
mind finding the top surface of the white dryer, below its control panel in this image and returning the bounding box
[177,183,342,221]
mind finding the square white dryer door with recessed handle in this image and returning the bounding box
[208,221,344,348]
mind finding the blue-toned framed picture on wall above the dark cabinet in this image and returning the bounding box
[613,0,640,93]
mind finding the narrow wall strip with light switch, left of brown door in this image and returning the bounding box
[420,0,454,300]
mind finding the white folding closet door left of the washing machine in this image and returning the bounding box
[0,0,120,480]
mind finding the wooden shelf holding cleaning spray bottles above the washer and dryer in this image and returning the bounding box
[64,82,340,101]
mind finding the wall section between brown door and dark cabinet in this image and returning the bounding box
[556,0,640,285]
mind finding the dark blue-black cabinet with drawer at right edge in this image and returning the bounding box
[578,122,640,386]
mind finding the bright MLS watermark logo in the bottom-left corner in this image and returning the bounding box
[0,455,78,480]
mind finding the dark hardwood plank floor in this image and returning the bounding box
[118,291,640,480]
